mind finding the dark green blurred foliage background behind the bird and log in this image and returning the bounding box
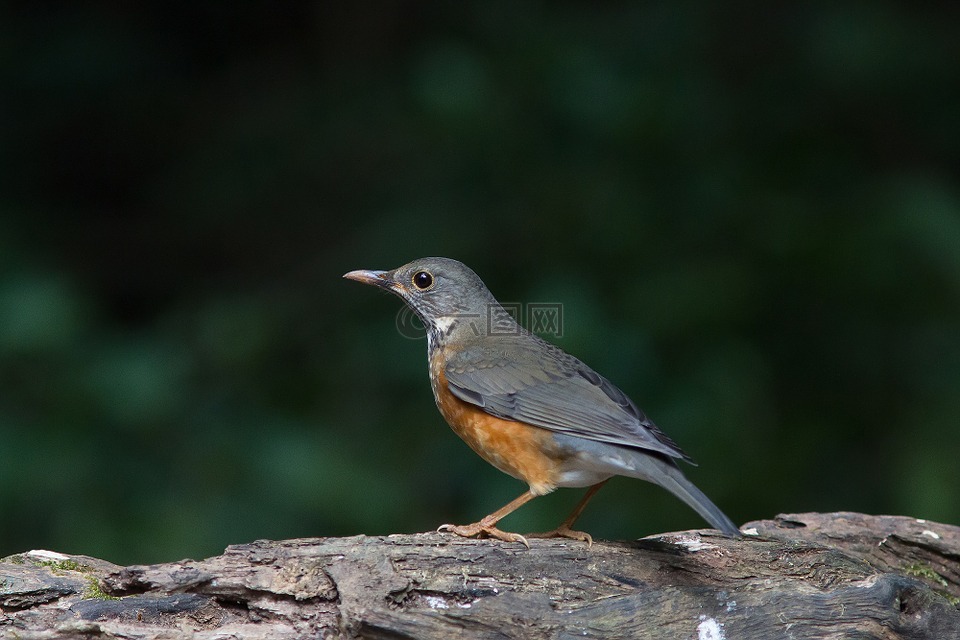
[0,0,960,563]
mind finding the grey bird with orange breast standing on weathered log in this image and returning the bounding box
[343,257,741,548]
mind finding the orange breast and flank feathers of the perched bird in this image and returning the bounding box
[430,350,561,495]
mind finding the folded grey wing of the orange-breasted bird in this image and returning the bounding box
[444,334,690,461]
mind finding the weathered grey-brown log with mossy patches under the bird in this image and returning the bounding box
[0,513,960,640]
